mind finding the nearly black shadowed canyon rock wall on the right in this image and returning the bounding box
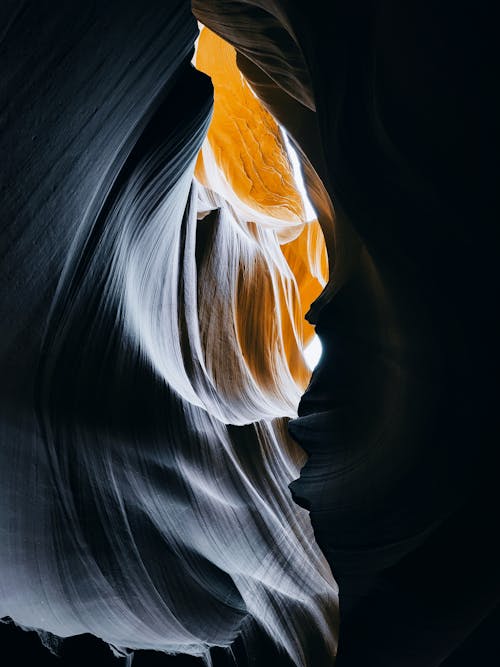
[194,1,500,666]
